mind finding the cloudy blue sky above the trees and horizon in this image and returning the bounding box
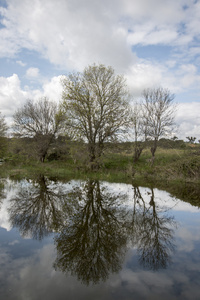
[0,0,200,140]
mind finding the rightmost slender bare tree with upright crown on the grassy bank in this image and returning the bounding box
[143,87,175,162]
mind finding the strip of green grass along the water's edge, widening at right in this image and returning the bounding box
[0,148,200,183]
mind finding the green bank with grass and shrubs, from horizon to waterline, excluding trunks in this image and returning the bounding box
[0,140,200,182]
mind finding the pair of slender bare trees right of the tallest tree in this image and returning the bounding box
[131,87,176,163]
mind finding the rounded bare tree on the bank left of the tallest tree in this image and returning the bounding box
[13,97,62,162]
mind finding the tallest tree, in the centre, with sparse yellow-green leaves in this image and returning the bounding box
[63,64,129,168]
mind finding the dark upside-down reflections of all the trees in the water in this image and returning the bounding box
[9,176,177,284]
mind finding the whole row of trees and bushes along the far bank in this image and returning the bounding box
[0,64,198,169]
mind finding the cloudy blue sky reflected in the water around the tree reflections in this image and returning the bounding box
[0,179,200,300]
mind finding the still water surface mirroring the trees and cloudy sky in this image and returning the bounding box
[0,176,200,300]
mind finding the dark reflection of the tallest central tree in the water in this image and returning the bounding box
[55,180,127,284]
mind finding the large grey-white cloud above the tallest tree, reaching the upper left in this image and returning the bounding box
[1,0,132,69]
